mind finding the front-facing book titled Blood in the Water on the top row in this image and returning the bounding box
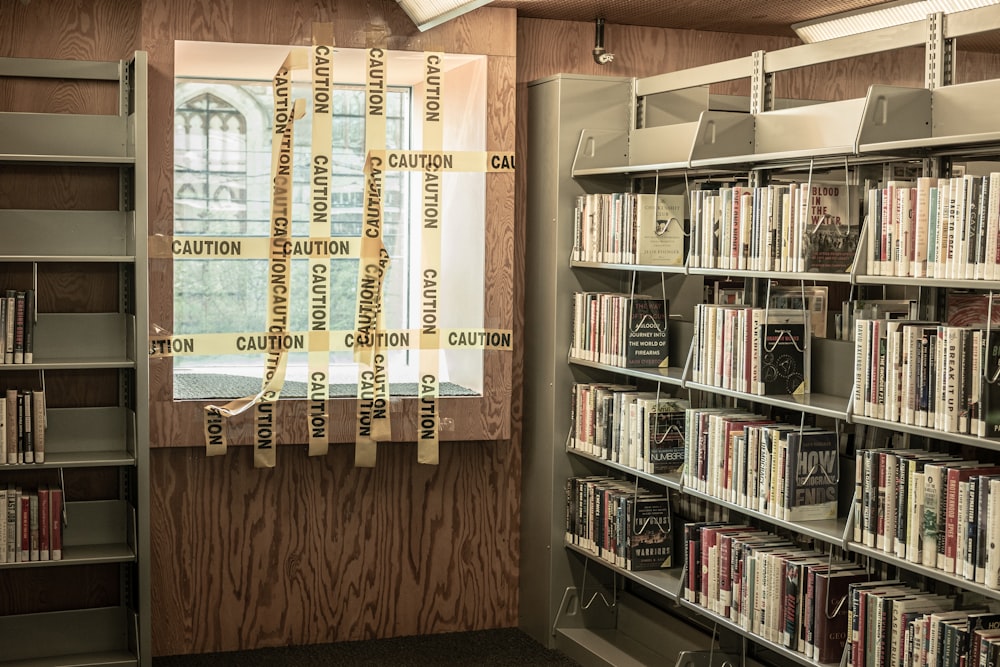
[801,181,861,273]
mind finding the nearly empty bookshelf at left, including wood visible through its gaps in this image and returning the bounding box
[0,52,152,665]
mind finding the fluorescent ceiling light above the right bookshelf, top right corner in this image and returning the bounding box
[792,0,1000,44]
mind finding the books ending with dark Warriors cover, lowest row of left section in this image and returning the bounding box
[566,476,673,571]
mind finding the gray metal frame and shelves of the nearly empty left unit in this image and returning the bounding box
[0,52,152,667]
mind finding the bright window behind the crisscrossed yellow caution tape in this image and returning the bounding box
[172,42,485,399]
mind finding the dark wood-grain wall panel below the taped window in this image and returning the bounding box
[152,443,518,655]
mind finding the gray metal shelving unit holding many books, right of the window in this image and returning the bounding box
[521,6,1000,665]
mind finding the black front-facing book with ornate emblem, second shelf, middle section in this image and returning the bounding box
[756,309,810,396]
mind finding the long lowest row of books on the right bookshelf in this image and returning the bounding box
[683,522,1000,667]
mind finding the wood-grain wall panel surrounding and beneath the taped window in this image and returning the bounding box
[142,0,520,655]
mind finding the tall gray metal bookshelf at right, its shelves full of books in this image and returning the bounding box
[521,7,1000,665]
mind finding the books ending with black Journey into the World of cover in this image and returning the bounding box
[570,292,670,368]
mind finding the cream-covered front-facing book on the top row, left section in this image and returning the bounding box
[635,194,685,266]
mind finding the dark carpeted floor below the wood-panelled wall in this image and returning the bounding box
[153,628,579,667]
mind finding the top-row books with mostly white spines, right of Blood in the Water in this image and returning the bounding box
[866,172,1000,280]
